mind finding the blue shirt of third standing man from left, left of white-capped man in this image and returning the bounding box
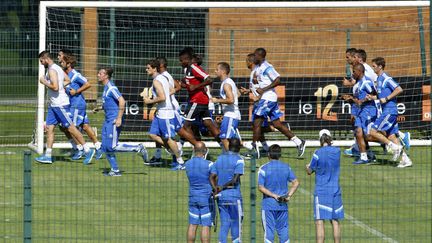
[258,160,297,210]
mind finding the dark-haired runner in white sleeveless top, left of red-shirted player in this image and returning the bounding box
[144,59,184,167]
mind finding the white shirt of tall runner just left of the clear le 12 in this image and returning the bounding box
[256,61,280,102]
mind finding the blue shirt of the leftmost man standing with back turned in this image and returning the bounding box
[186,157,213,205]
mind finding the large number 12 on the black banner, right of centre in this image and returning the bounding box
[314,84,339,121]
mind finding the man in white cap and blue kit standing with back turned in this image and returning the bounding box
[306,129,344,243]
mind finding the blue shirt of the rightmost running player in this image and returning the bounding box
[377,73,399,115]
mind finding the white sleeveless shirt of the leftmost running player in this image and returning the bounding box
[45,63,69,107]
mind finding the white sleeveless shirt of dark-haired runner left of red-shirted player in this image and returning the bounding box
[152,74,174,119]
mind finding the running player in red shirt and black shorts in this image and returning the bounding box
[179,47,220,145]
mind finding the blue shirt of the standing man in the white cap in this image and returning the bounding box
[310,146,340,196]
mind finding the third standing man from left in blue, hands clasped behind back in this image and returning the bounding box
[258,144,300,242]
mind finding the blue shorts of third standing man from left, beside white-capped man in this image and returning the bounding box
[261,210,289,242]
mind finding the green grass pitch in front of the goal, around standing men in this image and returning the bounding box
[0,147,432,242]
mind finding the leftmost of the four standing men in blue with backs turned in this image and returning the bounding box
[186,142,213,243]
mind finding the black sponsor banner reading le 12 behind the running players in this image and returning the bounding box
[116,77,431,131]
